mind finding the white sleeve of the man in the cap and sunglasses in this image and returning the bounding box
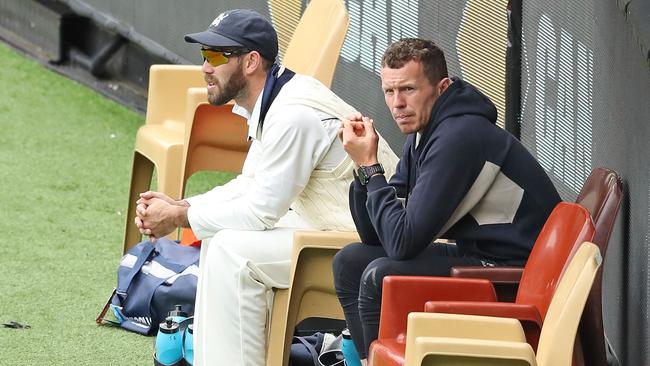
[188,105,331,239]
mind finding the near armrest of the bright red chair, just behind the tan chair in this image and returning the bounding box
[424,301,543,350]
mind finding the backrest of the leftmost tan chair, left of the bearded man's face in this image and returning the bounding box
[145,65,205,129]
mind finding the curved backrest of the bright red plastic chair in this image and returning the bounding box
[515,202,594,318]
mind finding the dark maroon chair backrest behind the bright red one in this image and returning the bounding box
[576,168,623,366]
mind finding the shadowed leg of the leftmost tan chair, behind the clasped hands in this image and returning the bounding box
[123,151,154,253]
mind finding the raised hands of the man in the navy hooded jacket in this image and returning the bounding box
[339,113,379,166]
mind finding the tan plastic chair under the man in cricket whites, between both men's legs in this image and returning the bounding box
[266,231,359,366]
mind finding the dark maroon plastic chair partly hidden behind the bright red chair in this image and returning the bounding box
[452,168,623,366]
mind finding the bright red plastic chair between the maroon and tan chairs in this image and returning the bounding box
[369,202,594,365]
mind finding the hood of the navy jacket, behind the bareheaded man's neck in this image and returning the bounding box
[423,77,497,137]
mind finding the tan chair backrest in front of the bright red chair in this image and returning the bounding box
[536,243,602,366]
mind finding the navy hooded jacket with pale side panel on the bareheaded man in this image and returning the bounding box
[350,78,560,264]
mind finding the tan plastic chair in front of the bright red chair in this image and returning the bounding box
[405,242,602,366]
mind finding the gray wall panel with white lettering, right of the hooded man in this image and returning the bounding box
[521,0,650,365]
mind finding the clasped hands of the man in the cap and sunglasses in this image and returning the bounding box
[135,191,189,241]
